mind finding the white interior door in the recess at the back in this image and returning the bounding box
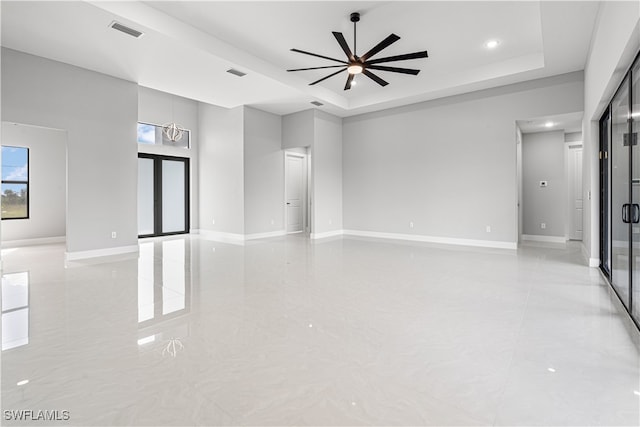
[285,154,306,233]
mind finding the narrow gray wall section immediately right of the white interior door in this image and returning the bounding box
[311,110,343,234]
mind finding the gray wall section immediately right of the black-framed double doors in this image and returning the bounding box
[198,103,244,234]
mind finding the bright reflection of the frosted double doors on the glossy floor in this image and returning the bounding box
[138,239,190,323]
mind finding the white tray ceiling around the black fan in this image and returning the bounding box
[1,0,599,117]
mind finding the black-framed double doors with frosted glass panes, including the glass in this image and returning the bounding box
[138,153,189,237]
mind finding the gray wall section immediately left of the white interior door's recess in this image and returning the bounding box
[244,107,284,234]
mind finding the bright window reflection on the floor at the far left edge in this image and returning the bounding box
[2,271,29,351]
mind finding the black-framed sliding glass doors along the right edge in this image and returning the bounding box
[600,51,640,327]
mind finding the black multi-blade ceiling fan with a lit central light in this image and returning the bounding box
[287,12,429,90]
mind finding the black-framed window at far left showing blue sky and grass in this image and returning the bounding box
[0,145,29,219]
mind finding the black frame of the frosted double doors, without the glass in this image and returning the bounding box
[138,153,191,238]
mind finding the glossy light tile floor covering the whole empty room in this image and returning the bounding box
[2,236,640,425]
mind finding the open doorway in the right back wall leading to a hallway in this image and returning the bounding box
[516,112,584,243]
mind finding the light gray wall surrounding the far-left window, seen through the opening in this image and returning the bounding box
[2,122,67,241]
